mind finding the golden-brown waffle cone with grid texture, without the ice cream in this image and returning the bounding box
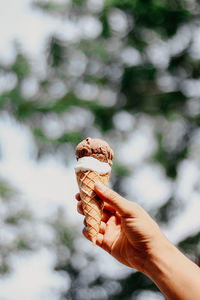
[76,171,110,245]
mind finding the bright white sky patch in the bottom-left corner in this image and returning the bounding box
[0,249,69,300]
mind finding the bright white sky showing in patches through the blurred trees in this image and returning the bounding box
[0,0,200,300]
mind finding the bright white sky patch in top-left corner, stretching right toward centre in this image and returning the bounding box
[0,0,102,62]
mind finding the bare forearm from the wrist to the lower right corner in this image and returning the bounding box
[145,238,200,300]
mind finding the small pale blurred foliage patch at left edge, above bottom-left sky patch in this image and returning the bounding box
[0,178,35,276]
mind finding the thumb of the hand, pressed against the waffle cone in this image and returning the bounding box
[94,182,134,217]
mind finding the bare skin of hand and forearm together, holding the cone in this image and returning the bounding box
[76,183,200,300]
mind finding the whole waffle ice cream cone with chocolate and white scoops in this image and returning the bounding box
[75,137,114,245]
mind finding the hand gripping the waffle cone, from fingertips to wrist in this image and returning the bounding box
[76,184,164,273]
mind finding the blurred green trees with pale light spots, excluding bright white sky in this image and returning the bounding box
[0,0,200,300]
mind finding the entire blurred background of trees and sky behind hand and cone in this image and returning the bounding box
[0,0,200,300]
